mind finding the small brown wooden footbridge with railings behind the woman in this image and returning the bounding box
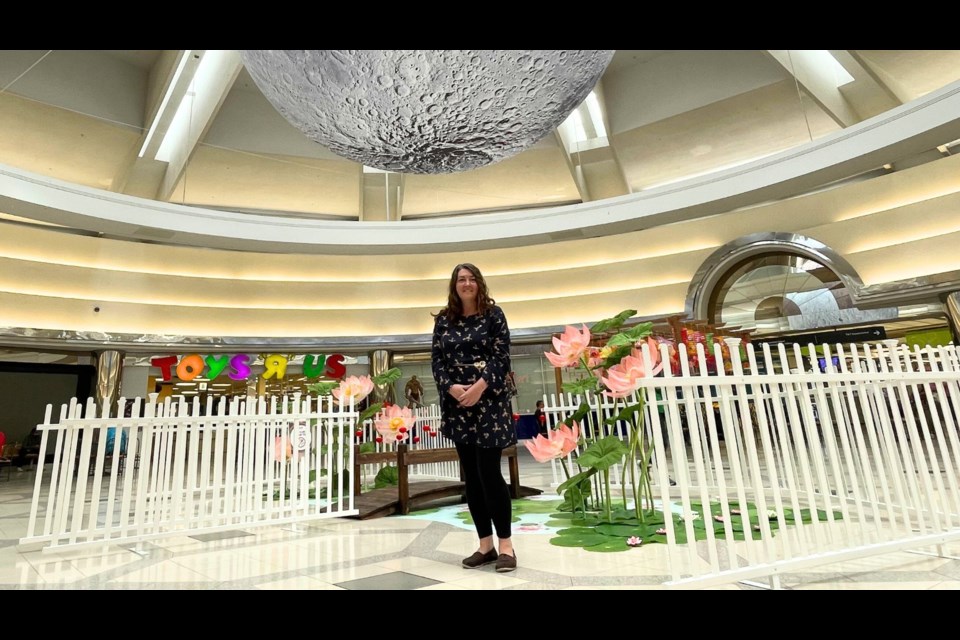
[353,444,542,518]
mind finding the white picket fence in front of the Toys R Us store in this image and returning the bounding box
[20,394,358,549]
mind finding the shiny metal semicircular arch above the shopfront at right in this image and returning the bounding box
[684,232,864,320]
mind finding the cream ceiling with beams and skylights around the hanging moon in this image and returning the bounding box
[0,50,960,242]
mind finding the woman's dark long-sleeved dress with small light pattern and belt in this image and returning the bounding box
[433,306,517,449]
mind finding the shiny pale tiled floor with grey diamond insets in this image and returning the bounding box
[0,449,960,590]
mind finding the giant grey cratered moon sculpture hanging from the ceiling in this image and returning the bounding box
[240,50,614,174]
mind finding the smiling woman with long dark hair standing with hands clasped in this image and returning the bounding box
[432,263,517,573]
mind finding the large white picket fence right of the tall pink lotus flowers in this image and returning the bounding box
[545,345,960,587]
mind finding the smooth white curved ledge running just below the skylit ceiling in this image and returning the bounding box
[0,82,960,254]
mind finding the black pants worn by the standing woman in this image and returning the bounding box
[456,442,513,540]
